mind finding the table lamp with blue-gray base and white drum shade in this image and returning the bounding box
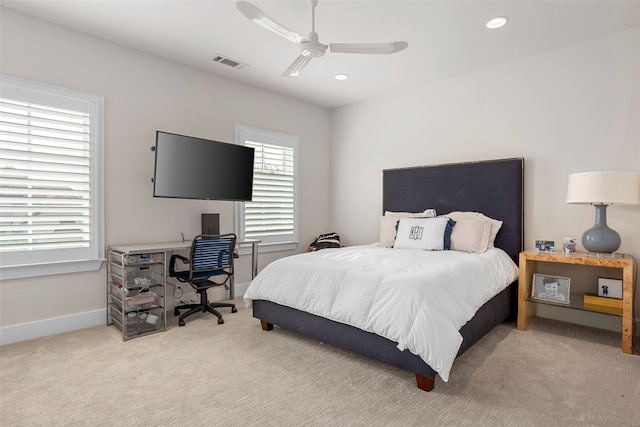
[567,171,640,253]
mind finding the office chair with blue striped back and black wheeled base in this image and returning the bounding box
[169,233,238,326]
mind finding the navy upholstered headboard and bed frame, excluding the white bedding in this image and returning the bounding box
[245,158,524,391]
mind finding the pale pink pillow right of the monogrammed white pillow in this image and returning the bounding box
[445,211,502,253]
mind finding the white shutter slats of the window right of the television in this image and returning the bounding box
[245,141,295,238]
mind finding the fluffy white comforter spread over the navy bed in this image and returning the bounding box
[244,245,518,381]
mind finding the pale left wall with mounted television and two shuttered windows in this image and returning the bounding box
[0,8,330,342]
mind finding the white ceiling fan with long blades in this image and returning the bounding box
[236,0,409,77]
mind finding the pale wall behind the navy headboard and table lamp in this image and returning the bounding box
[331,27,640,330]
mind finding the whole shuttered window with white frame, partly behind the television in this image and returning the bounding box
[235,125,298,253]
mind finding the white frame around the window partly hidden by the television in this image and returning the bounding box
[234,124,300,255]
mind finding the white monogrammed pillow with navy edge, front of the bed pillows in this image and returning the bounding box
[393,217,455,251]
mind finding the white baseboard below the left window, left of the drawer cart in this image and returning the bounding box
[0,309,107,345]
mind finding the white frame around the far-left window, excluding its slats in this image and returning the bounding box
[0,74,105,280]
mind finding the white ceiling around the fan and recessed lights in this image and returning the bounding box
[1,0,640,108]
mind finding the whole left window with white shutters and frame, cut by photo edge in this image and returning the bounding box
[0,75,104,279]
